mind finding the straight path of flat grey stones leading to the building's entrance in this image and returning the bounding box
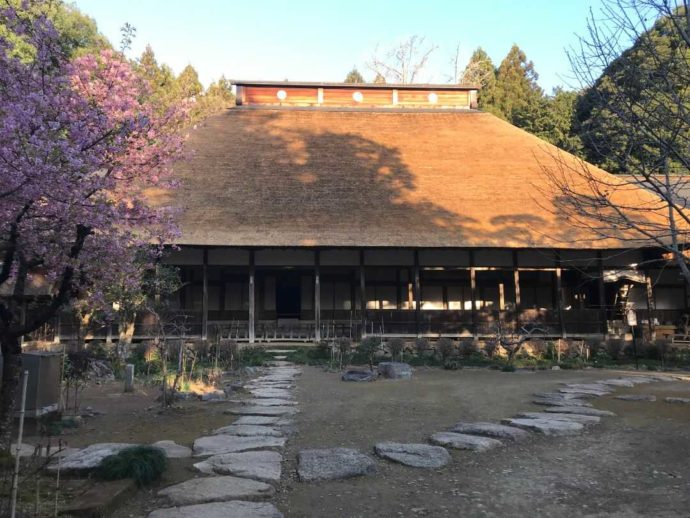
[149,349,301,518]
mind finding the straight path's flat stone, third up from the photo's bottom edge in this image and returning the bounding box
[194,451,283,483]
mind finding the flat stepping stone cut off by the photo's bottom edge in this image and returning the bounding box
[148,500,283,518]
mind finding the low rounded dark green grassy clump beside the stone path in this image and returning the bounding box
[96,446,168,486]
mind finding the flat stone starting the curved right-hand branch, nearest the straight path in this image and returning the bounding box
[297,448,376,482]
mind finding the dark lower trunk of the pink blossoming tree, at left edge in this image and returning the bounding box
[0,335,22,451]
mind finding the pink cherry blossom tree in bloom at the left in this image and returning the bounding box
[0,8,185,446]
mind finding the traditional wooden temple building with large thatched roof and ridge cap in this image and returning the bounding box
[95,81,688,342]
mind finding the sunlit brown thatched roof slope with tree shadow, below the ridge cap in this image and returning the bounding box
[152,107,668,248]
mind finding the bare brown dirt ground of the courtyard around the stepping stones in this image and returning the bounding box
[22,367,690,518]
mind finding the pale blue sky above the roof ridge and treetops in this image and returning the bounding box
[75,0,600,92]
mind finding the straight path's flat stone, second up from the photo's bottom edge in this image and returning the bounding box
[158,475,275,505]
